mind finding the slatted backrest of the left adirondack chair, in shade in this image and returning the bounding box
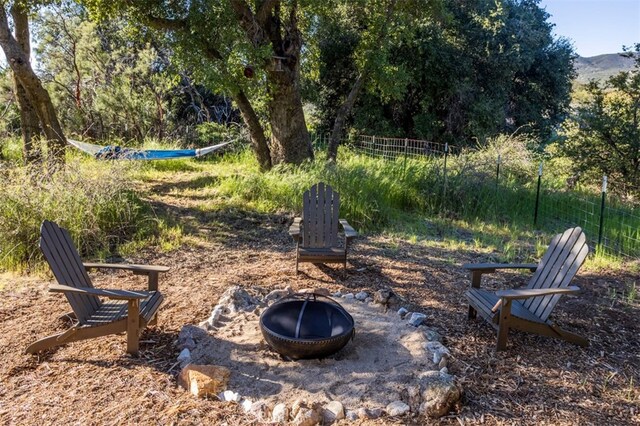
[40,220,101,324]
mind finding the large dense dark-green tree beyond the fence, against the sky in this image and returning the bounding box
[310,0,574,144]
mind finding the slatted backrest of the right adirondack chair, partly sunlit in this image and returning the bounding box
[523,227,589,320]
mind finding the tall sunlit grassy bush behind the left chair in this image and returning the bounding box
[0,159,154,270]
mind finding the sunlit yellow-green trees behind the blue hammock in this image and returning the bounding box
[35,2,238,143]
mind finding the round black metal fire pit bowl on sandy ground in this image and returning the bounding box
[260,293,355,359]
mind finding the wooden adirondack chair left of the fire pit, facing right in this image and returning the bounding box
[26,220,169,354]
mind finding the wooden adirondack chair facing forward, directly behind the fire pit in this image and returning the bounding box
[289,182,358,274]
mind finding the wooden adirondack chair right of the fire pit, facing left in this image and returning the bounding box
[463,228,589,350]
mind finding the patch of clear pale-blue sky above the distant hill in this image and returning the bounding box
[540,0,640,57]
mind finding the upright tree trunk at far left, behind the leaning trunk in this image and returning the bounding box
[11,3,41,165]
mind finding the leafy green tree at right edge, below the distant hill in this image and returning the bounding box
[563,43,640,196]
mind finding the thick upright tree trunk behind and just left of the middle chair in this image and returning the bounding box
[267,60,313,164]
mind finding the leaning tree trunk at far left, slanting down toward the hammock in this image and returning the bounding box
[0,7,67,162]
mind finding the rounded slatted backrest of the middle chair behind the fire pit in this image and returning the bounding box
[302,182,340,248]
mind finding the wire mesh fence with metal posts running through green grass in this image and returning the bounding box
[336,135,640,258]
